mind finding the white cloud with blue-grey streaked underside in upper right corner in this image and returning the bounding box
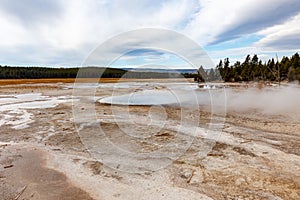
[185,0,300,45]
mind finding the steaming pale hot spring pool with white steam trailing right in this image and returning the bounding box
[100,82,300,119]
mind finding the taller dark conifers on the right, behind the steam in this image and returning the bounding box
[195,53,300,82]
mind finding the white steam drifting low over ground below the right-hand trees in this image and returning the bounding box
[192,83,300,119]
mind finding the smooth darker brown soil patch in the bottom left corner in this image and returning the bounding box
[0,145,92,200]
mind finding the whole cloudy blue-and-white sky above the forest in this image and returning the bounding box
[0,0,300,68]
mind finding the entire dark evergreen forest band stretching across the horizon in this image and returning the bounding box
[0,53,300,83]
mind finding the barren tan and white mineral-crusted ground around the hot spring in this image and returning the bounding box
[0,81,300,200]
